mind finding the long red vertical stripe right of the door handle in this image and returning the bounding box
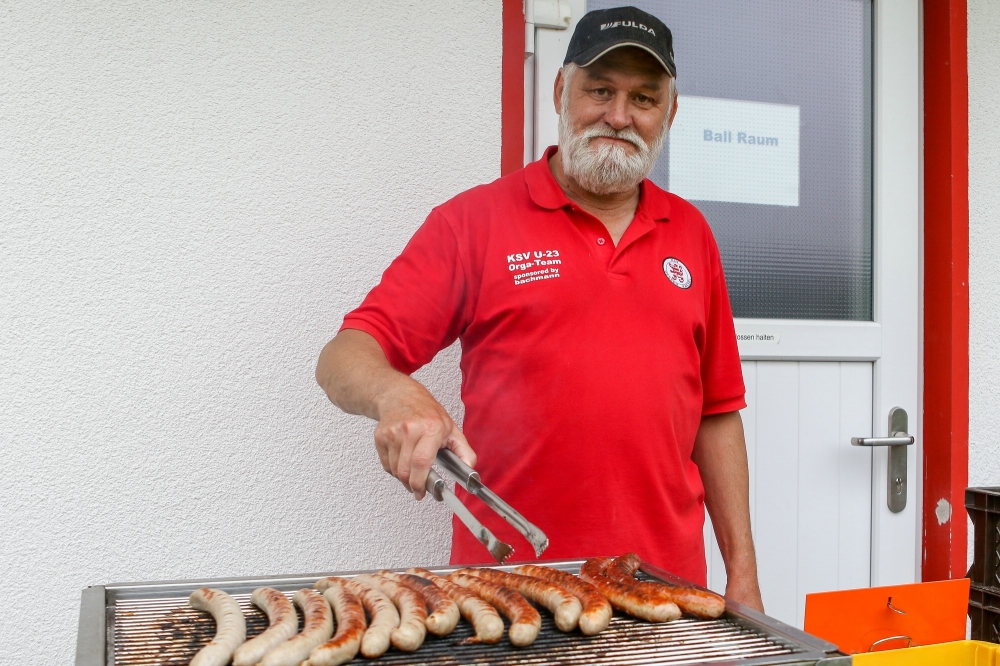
[922,0,969,580]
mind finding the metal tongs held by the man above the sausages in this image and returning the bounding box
[427,449,549,564]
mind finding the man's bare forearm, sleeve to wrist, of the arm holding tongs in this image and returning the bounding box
[316,329,423,421]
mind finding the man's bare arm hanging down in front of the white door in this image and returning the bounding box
[691,412,764,612]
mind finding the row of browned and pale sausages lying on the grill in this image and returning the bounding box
[184,553,725,666]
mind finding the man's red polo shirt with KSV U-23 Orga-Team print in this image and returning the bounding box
[343,148,746,584]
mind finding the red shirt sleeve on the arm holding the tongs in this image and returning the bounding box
[340,209,467,374]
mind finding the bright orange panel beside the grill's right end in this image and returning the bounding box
[805,578,969,654]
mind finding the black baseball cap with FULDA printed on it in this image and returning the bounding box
[563,7,677,77]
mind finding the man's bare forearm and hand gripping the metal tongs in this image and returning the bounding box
[316,329,476,499]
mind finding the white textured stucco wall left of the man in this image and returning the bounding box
[0,0,501,664]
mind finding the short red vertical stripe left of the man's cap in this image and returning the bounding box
[500,0,524,175]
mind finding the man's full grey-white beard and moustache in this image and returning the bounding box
[559,110,669,195]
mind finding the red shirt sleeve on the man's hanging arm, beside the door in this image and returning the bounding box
[701,232,747,416]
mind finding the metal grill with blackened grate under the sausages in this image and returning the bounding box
[76,561,850,666]
